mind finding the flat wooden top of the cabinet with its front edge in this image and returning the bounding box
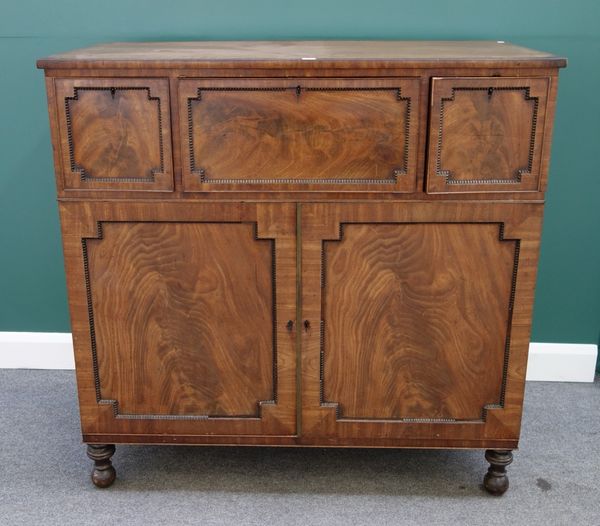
[37,40,566,69]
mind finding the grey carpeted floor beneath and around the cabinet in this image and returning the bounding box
[0,370,600,526]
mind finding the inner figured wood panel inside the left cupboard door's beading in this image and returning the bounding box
[84,222,276,418]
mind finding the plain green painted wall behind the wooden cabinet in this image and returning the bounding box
[0,0,600,343]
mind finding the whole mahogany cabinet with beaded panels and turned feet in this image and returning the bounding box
[38,41,566,494]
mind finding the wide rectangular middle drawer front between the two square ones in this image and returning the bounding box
[179,78,419,192]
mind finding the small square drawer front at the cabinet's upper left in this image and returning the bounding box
[55,78,173,191]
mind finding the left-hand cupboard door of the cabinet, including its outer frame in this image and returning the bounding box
[61,203,296,442]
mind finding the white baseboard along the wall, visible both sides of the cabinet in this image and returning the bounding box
[0,332,598,382]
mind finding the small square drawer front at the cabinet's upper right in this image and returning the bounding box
[427,77,549,193]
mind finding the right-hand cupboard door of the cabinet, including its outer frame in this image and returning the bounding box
[302,203,542,447]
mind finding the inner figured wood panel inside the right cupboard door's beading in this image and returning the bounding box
[322,223,517,421]
